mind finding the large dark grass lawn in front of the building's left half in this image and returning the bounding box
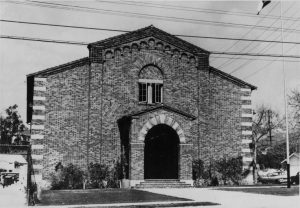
[37,189,204,206]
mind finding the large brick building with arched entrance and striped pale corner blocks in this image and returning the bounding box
[27,26,256,186]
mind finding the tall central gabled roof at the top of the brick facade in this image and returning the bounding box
[88,25,209,55]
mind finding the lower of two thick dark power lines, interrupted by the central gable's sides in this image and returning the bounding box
[0,35,300,58]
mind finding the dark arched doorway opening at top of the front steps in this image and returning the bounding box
[144,124,179,179]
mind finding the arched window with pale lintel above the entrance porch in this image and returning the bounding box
[138,65,163,104]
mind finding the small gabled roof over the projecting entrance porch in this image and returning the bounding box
[127,104,196,120]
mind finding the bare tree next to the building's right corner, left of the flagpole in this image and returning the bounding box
[252,106,282,183]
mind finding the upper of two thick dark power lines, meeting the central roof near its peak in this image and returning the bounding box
[0,19,300,45]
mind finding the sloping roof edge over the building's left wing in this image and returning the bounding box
[26,57,90,77]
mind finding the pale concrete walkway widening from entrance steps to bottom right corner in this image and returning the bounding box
[146,187,300,208]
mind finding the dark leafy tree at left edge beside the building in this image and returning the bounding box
[0,105,29,145]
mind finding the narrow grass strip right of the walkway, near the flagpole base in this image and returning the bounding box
[216,186,299,196]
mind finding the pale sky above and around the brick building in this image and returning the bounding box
[0,0,300,121]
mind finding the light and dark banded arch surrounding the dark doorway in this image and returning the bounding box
[138,114,186,143]
